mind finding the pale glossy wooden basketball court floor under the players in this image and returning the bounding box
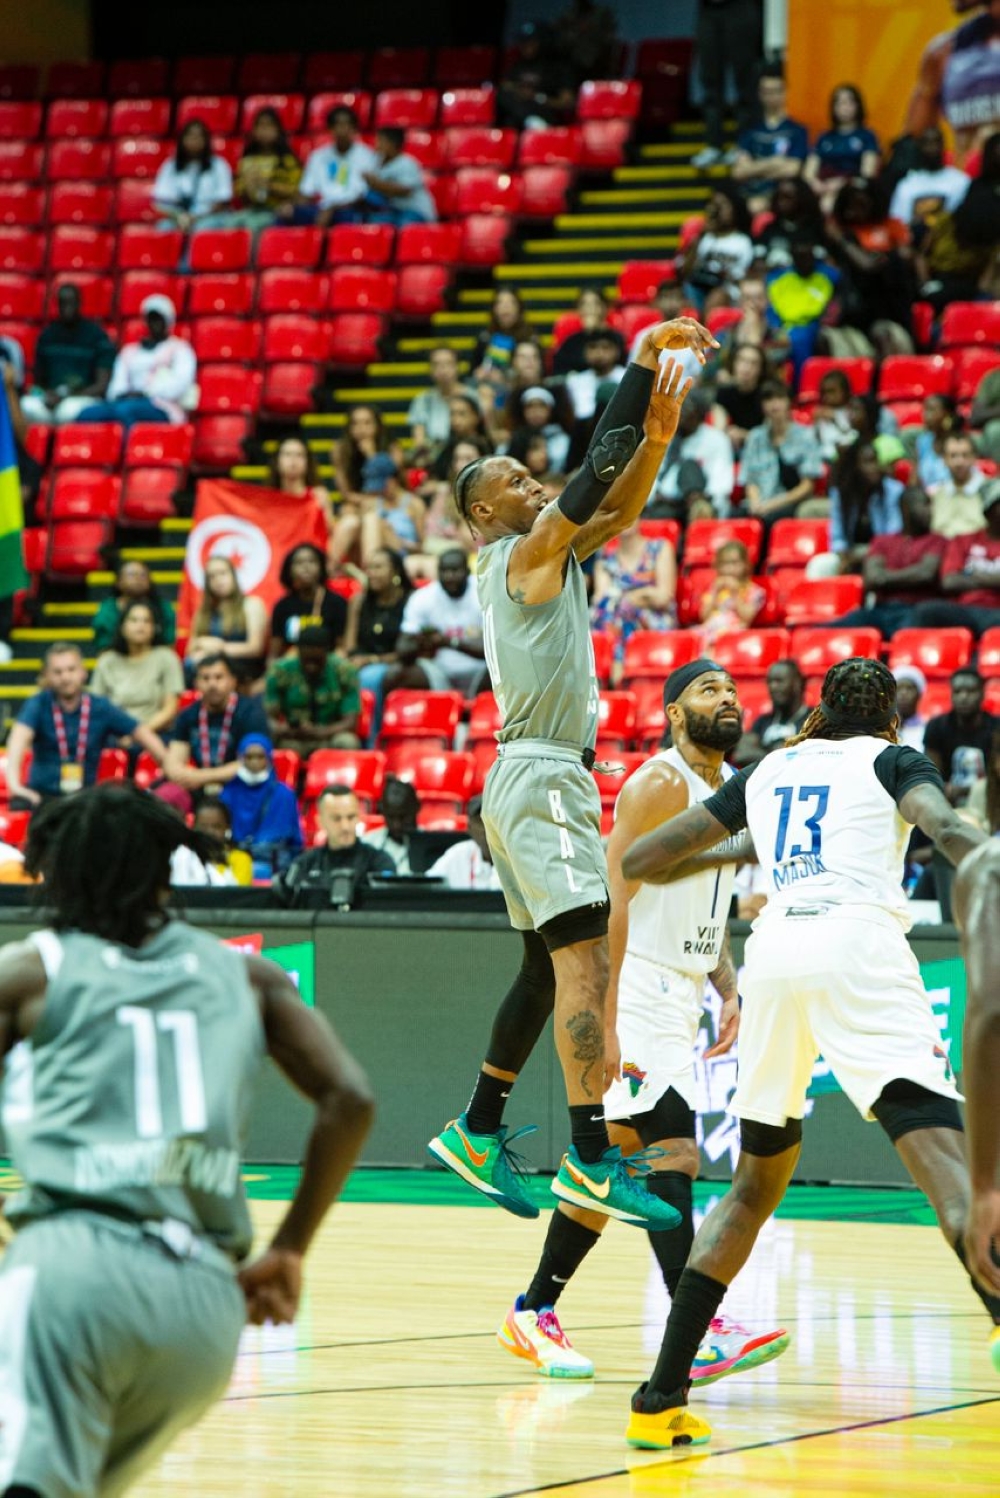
[135,1201,1000,1498]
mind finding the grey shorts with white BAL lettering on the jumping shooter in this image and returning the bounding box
[482,755,608,930]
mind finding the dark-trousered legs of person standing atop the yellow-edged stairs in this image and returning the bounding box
[692,0,760,171]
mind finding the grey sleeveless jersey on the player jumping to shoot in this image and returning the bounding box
[476,536,597,749]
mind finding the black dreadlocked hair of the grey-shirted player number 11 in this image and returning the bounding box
[24,782,220,947]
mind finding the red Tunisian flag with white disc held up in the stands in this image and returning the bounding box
[177,478,326,635]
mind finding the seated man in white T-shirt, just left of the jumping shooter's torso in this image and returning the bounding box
[386,548,485,695]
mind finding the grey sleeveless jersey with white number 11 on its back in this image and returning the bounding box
[3,921,263,1257]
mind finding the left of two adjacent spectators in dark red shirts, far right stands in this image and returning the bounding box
[834,488,948,640]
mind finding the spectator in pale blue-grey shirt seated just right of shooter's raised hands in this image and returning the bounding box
[740,380,823,527]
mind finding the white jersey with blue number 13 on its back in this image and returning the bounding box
[747,737,910,930]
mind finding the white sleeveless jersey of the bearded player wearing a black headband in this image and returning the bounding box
[627,749,737,977]
